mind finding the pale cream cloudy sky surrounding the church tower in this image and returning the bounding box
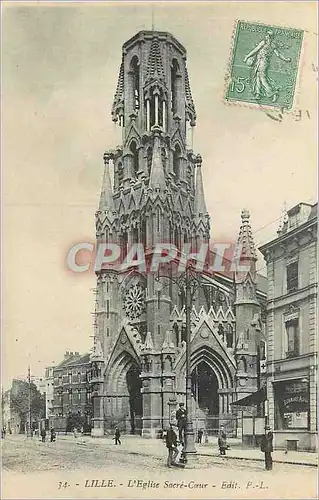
[2,1,318,385]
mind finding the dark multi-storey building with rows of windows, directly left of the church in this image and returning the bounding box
[52,351,91,432]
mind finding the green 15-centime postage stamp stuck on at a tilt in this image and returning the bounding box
[226,21,303,109]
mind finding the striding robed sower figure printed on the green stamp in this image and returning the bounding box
[244,30,291,102]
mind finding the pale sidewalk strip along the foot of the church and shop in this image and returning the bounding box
[58,435,318,467]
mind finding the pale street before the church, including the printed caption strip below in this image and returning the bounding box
[2,436,317,499]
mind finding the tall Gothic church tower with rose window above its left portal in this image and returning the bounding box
[95,31,210,434]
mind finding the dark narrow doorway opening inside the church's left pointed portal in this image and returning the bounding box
[126,365,143,434]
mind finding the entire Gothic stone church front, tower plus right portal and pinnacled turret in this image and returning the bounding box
[91,31,266,436]
